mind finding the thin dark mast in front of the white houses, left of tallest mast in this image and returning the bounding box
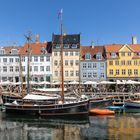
[25,32,31,93]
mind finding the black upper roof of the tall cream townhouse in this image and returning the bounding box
[52,34,80,44]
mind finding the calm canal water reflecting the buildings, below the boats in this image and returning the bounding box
[0,109,140,140]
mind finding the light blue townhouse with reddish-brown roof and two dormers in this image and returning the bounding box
[80,45,106,82]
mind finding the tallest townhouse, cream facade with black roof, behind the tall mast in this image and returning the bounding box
[52,34,80,83]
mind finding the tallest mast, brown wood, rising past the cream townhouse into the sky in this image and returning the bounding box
[60,9,64,103]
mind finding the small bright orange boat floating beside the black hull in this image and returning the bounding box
[89,109,115,115]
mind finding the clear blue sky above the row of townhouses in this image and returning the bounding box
[0,0,140,46]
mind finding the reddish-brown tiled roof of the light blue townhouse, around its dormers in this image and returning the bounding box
[80,46,104,60]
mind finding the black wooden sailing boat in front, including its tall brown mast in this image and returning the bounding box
[5,9,88,117]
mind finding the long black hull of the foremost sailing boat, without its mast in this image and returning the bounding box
[5,101,88,117]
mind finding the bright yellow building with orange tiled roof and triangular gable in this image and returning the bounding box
[105,44,140,80]
